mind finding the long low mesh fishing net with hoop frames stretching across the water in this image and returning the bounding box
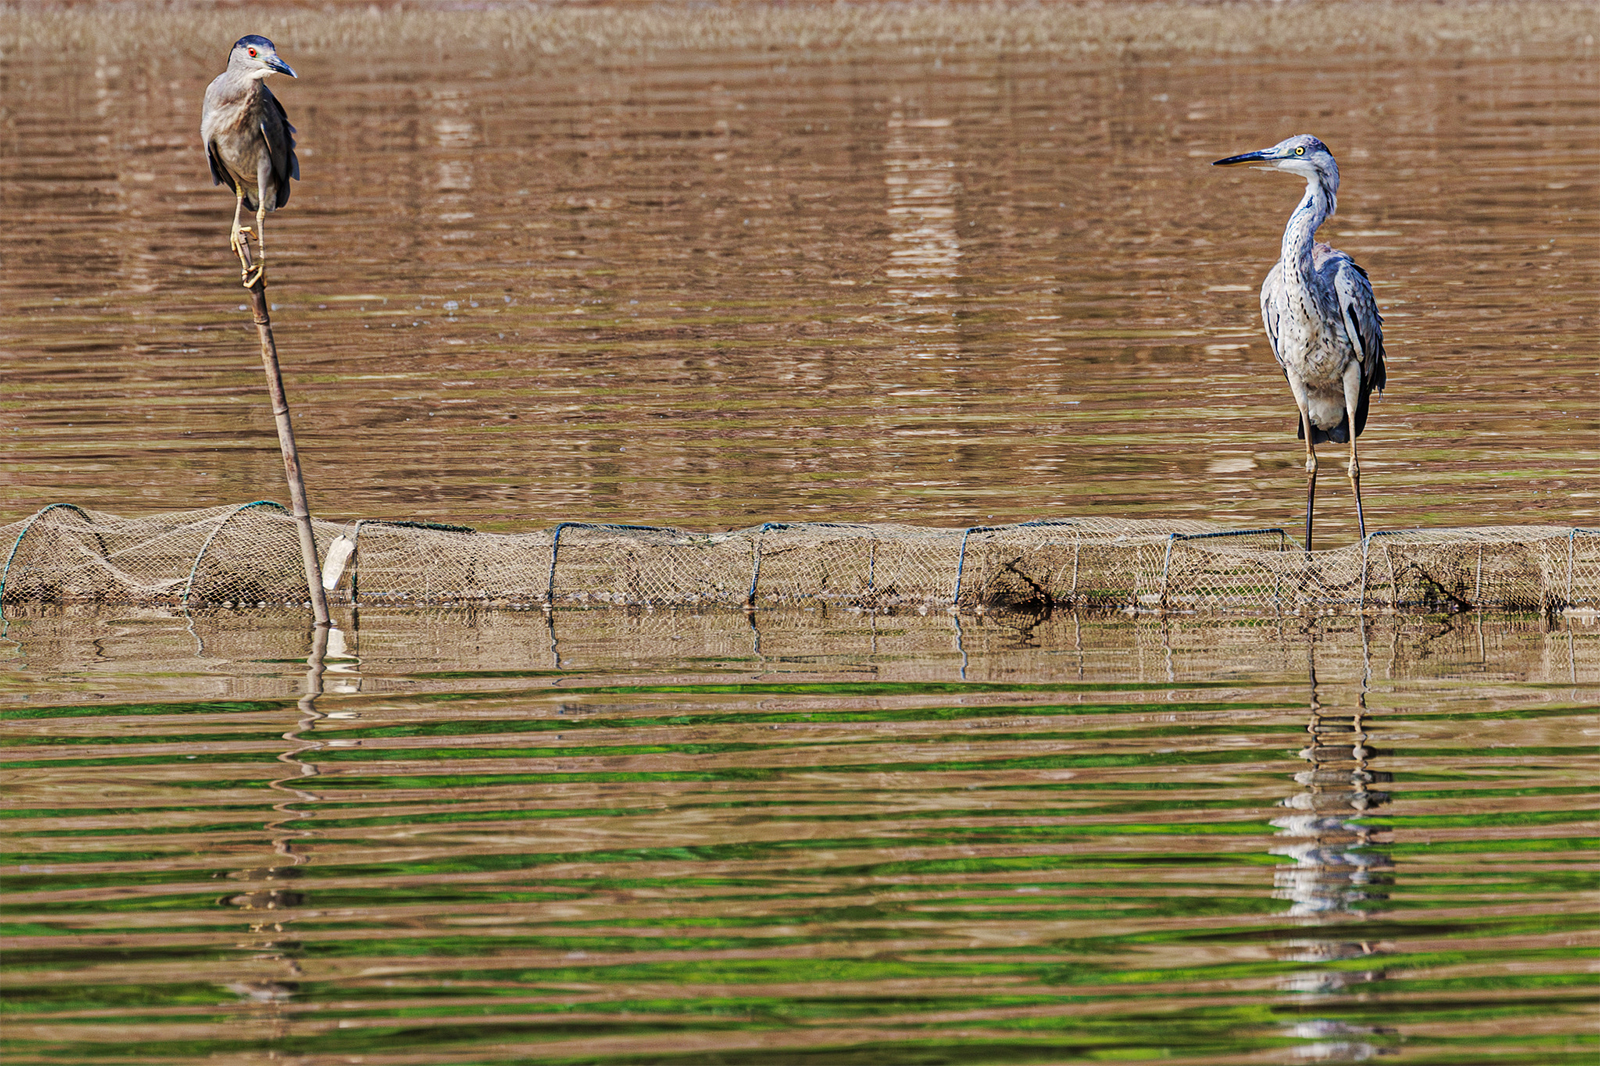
[0,501,1600,615]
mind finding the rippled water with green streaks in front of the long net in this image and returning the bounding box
[5,607,1600,1063]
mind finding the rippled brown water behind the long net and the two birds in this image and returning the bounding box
[0,5,1600,544]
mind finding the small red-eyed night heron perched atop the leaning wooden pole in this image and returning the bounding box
[200,34,299,288]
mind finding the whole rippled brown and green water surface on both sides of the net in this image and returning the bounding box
[0,5,1600,1066]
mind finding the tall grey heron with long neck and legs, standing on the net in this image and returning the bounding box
[1213,133,1387,551]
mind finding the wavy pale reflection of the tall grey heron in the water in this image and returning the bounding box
[1270,650,1394,1061]
